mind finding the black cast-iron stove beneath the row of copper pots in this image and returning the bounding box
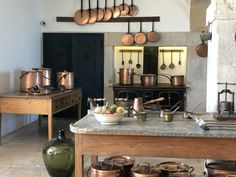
[113,84,187,111]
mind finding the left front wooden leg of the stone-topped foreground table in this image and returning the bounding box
[75,134,84,177]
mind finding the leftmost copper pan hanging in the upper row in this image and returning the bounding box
[74,0,89,25]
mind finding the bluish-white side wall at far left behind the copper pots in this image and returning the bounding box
[0,0,42,135]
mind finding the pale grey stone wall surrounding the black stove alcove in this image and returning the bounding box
[104,32,207,111]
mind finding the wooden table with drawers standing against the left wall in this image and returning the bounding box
[0,89,82,144]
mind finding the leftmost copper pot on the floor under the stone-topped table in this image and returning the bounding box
[91,162,121,177]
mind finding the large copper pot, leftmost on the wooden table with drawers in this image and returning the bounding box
[20,70,43,92]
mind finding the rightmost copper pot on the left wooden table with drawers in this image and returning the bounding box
[57,71,74,89]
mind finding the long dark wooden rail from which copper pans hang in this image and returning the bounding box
[56,16,160,23]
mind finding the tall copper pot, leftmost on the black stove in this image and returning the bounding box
[118,68,134,85]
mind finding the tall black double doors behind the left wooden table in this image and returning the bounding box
[43,33,104,116]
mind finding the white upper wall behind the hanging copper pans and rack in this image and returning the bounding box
[43,0,190,32]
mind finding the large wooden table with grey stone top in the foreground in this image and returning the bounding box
[70,114,236,177]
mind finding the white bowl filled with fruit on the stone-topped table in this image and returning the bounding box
[92,104,128,125]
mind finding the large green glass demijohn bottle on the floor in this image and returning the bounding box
[42,130,75,177]
